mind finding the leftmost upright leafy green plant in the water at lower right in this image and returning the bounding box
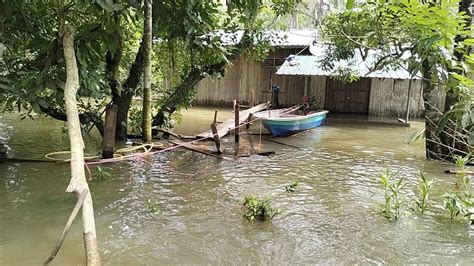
[380,169,406,220]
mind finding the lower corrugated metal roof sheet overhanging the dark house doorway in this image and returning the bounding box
[276,45,419,79]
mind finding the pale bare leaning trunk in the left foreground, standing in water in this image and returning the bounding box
[63,25,101,265]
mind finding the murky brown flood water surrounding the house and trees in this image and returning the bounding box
[0,108,474,265]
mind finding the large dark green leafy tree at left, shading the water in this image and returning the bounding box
[0,0,298,140]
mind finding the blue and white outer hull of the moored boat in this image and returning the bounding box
[254,111,328,136]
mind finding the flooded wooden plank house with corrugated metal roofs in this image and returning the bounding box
[194,30,445,117]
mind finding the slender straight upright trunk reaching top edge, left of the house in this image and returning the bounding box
[142,0,152,143]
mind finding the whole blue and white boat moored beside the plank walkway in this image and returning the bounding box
[253,108,329,136]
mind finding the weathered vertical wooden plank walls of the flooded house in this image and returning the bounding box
[194,53,445,117]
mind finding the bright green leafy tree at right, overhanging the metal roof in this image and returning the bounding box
[323,0,474,159]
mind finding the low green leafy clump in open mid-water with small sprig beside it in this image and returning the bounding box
[244,181,298,222]
